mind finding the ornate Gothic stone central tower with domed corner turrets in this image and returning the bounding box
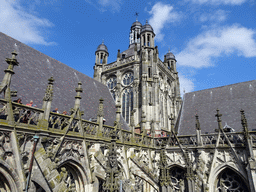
[94,20,181,135]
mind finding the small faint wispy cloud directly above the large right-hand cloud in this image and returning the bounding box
[199,10,227,22]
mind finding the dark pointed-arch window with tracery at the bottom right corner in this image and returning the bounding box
[216,168,249,192]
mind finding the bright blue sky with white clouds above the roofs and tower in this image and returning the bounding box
[0,0,256,93]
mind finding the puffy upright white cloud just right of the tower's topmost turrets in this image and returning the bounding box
[149,2,180,41]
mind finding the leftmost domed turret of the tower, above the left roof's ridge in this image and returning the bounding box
[93,41,108,82]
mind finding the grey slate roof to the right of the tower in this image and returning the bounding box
[178,80,256,135]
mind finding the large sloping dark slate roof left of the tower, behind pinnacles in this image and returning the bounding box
[0,32,129,129]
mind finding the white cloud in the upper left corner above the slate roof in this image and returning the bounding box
[0,0,53,45]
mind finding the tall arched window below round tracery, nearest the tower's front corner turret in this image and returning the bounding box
[122,88,133,124]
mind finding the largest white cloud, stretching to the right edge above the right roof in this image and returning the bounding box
[176,25,256,68]
